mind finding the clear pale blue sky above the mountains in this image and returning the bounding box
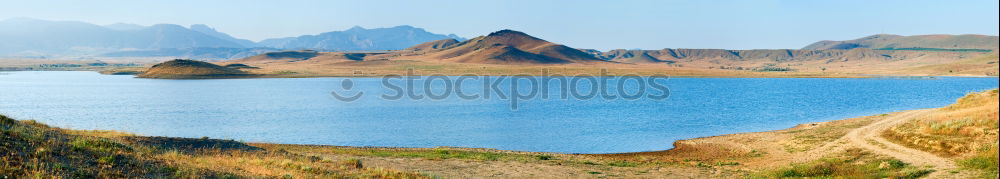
[0,0,1000,50]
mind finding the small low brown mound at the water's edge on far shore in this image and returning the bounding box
[138,59,253,79]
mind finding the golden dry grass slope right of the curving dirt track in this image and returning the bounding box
[883,89,1000,178]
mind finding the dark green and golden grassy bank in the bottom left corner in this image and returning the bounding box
[0,115,430,178]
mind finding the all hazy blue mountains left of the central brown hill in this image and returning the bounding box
[0,18,464,58]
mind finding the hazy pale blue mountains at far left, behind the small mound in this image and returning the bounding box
[0,18,254,56]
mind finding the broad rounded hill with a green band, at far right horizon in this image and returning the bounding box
[802,34,1000,50]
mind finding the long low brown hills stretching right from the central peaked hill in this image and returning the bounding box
[584,34,998,64]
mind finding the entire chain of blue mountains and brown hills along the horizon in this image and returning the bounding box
[0,18,998,60]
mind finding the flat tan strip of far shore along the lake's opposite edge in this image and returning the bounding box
[0,53,997,79]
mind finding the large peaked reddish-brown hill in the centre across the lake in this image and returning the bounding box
[408,30,601,64]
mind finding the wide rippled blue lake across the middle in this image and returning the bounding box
[0,72,998,153]
